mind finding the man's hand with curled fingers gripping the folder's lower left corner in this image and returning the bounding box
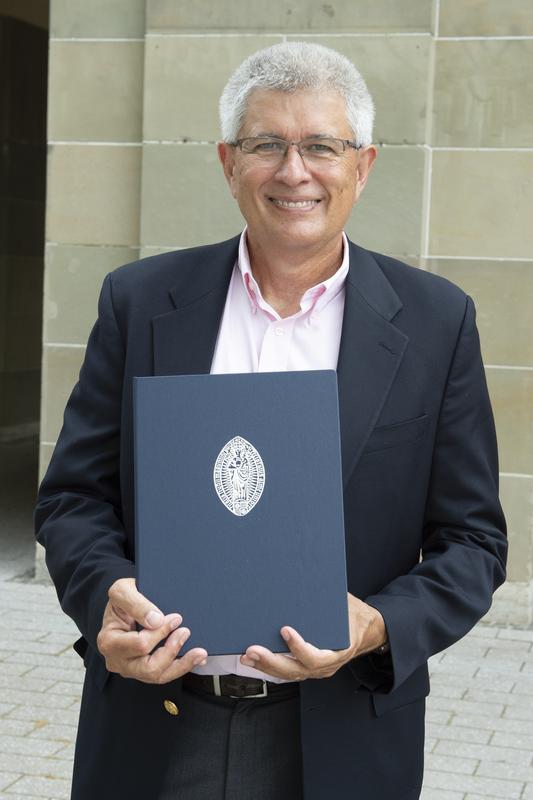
[96,578,207,683]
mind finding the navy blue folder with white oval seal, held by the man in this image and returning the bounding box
[134,370,349,655]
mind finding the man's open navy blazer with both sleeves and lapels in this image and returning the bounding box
[35,237,507,800]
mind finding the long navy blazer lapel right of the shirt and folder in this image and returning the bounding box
[337,242,409,488]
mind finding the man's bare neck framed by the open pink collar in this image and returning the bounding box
[246,231,343,317]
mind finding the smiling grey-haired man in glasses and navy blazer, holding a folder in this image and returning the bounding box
[36,43,506,800]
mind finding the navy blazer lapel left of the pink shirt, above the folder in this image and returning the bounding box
[152,236,239,375]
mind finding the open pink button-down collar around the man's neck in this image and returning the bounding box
[237,228,350,319]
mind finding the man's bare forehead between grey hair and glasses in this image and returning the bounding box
[239,89,352,138]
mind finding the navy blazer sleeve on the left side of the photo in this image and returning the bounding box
[35,276,135,648]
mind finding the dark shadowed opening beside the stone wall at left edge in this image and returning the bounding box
[0,0,48,578]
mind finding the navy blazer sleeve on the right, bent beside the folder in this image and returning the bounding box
[350,297,507,693]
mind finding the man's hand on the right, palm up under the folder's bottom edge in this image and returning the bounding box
[241,594,387,681]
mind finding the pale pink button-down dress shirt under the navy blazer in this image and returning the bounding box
[193,229,348,683]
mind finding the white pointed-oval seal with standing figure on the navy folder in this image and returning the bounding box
[213,436,265,517]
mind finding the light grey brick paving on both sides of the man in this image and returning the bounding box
[0,440,533,800]
